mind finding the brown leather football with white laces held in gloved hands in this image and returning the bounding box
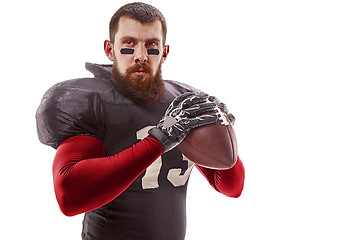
[178,109,238,170]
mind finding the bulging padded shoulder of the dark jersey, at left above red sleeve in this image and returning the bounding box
[36,78,112,148]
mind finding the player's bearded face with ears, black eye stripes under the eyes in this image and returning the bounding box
[104,17,169,102]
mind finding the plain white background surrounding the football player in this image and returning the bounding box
[0,0,360,240]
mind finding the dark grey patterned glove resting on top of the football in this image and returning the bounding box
[148,92,218,153]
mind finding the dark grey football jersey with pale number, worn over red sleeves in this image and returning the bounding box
[36,63,198,240]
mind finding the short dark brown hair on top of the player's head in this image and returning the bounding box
[109,2,167,44]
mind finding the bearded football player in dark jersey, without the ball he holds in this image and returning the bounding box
[36,3,244,240]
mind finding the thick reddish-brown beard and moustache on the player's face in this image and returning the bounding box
[111,60,166,106]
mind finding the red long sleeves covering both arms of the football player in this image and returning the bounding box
[53,136,244,216]
